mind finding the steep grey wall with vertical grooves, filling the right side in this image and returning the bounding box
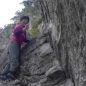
[38,0,86,86]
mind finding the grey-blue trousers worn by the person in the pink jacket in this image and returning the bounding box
[2,41,20,74]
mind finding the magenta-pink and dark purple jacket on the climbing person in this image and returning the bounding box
[10,24,26,45]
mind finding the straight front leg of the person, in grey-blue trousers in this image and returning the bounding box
[8,41,20,73]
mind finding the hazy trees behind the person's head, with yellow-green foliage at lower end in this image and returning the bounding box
[12,0,42,37]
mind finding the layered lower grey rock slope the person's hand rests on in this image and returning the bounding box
[0,34,73,86]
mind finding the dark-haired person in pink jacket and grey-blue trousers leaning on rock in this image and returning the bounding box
[0,16,29,80]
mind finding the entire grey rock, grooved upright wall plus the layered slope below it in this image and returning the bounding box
[1,0,86,86]
